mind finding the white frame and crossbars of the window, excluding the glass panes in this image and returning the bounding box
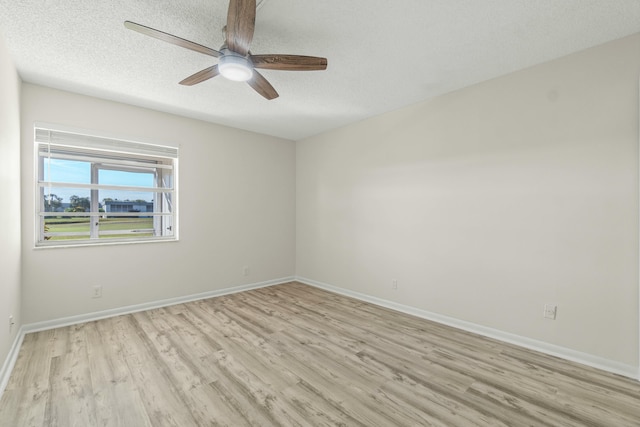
[34,123,178,247]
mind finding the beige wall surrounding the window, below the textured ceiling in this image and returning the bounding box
[22,84,295,323]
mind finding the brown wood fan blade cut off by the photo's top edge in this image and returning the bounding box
[227,0,256,56]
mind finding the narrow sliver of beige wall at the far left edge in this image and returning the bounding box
[0,38,21,369]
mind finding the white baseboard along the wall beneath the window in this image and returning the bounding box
[22,277,295,333]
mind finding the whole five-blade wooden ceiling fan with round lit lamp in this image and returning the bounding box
[124,0,327,99]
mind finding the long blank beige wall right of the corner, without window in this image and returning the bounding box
[296,35,640,367]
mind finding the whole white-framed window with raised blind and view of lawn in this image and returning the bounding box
[35,125,178,246]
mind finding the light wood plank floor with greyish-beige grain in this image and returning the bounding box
[0,283,640,427]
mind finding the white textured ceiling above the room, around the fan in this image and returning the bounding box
[0,0,640,140]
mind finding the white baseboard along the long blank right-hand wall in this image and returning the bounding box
[295,277,640,381]
